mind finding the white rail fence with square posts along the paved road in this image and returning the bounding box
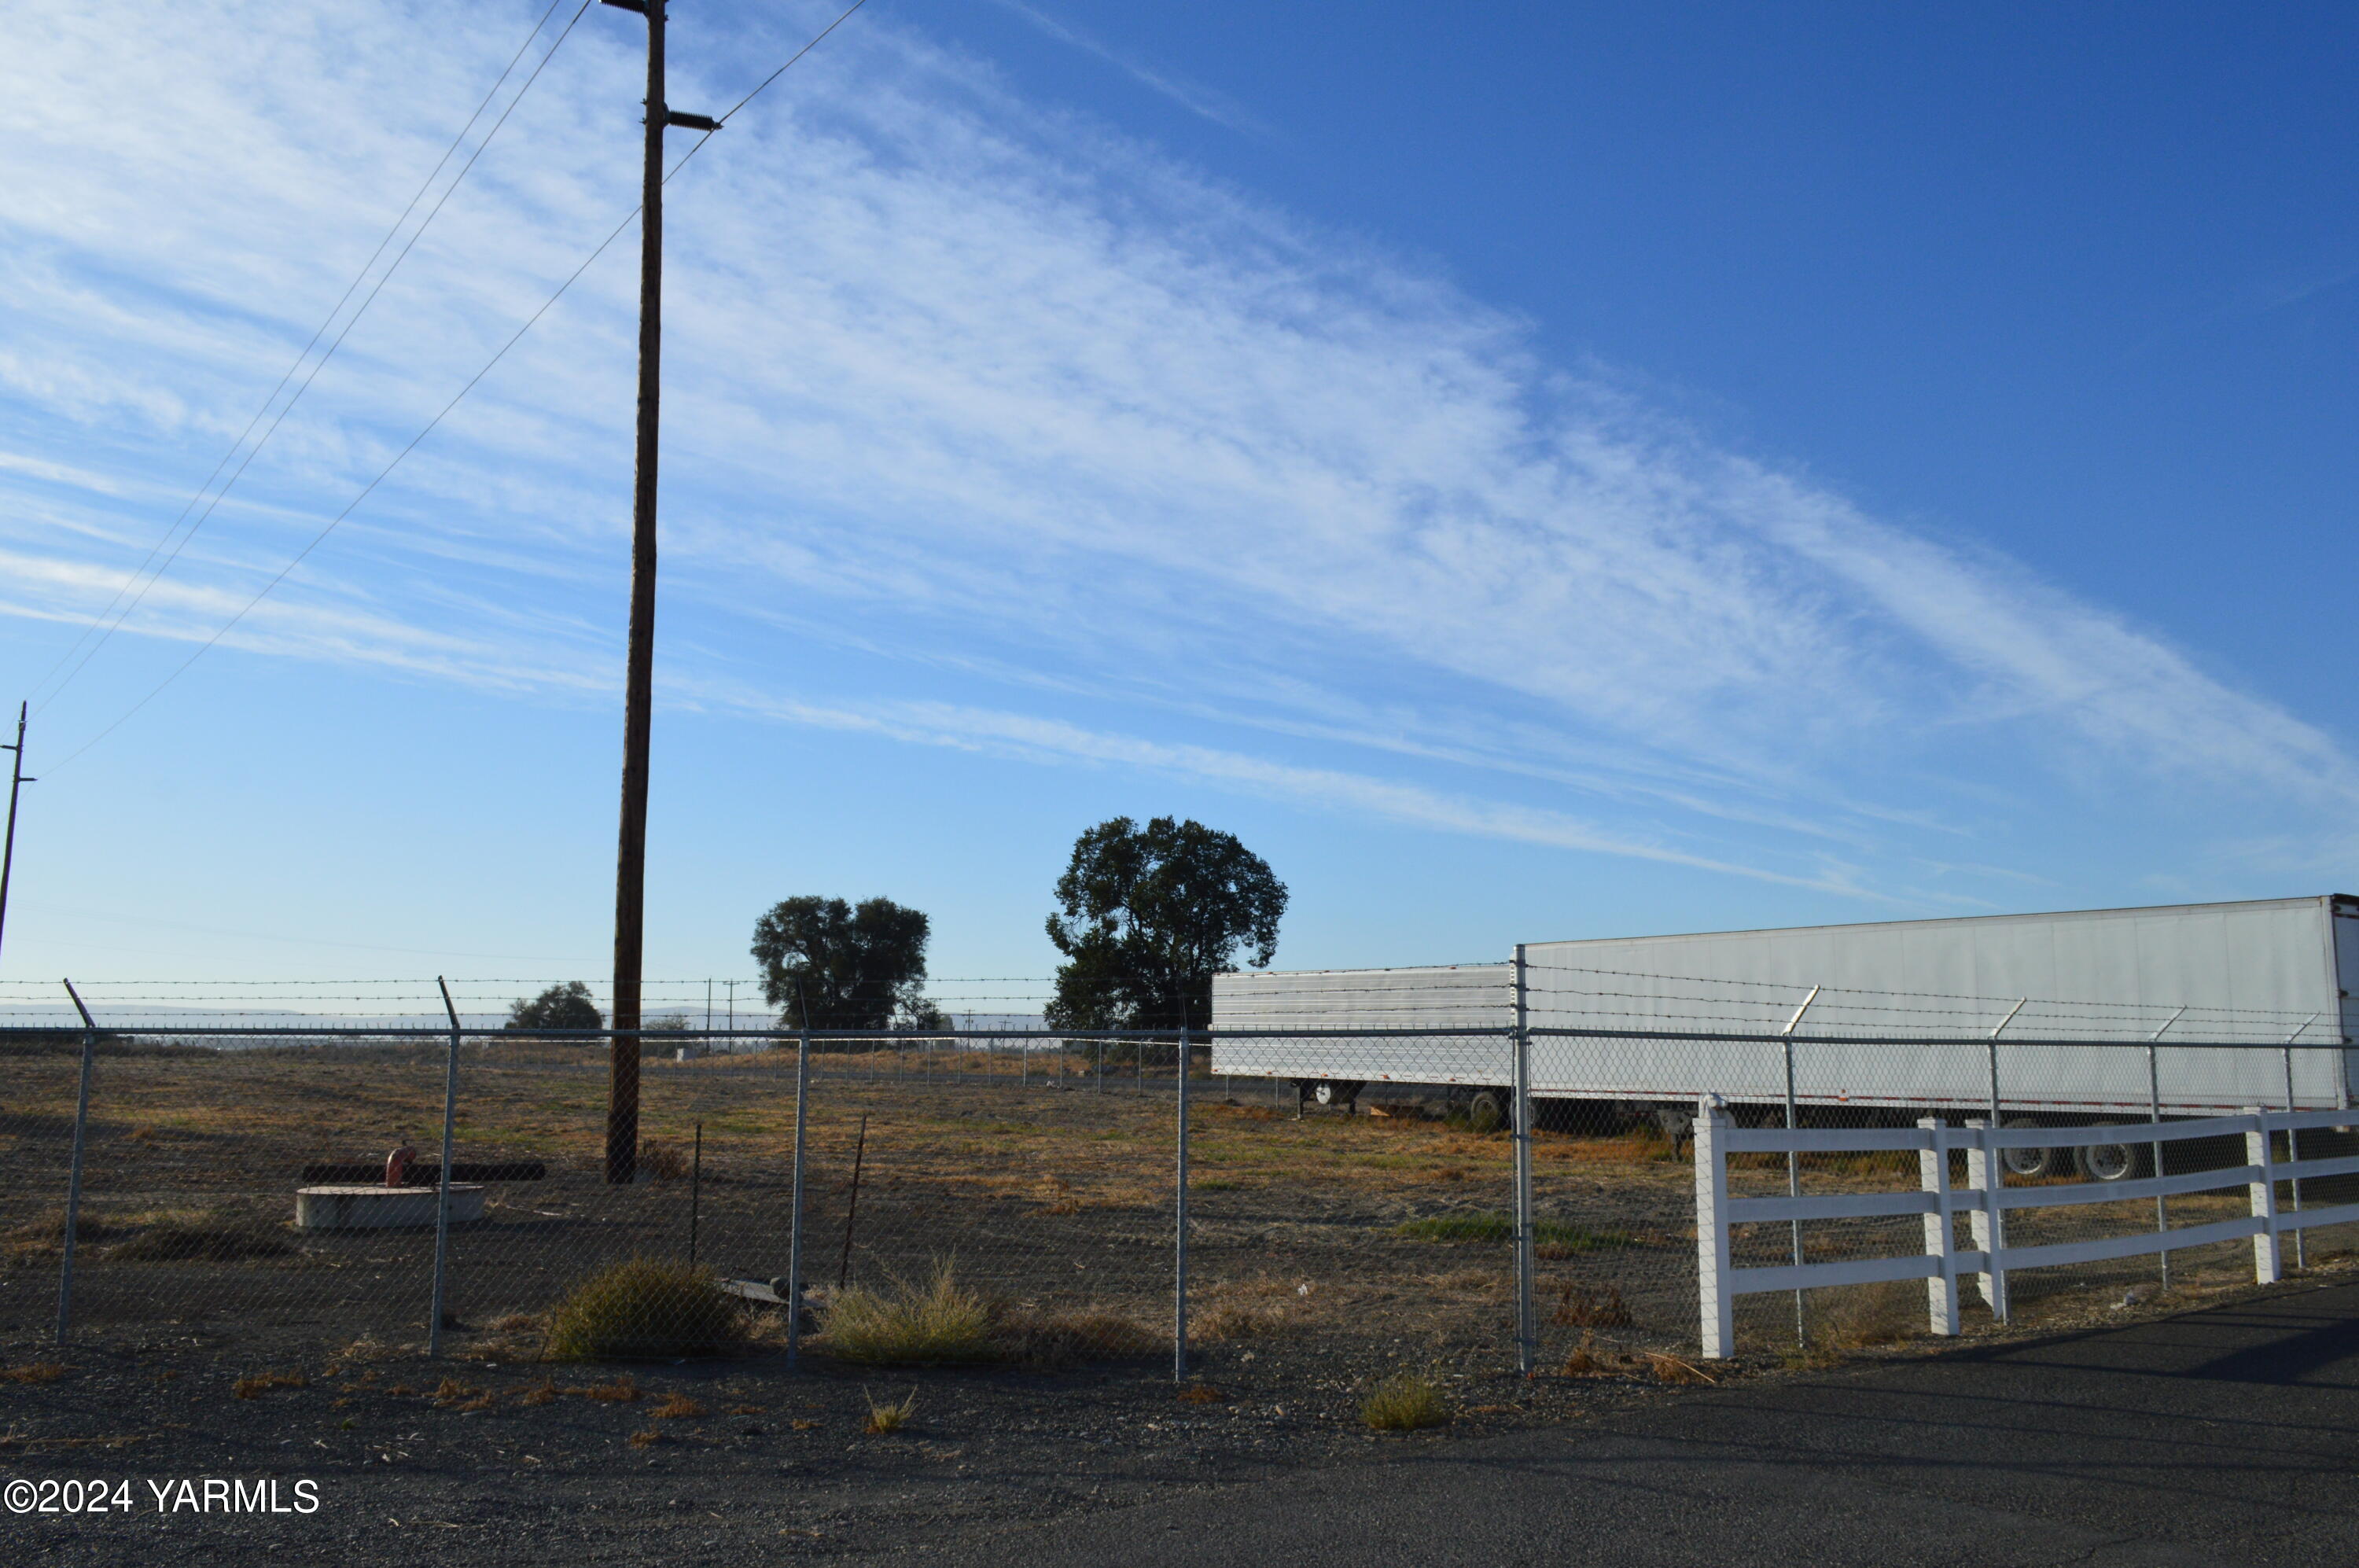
[1696,1101,2359,1358]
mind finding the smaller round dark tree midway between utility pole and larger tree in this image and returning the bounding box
[753,893,944,1028]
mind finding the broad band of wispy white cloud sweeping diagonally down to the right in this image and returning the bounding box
[0,0,2359,896]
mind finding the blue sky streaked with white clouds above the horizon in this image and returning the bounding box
[0,0,2359,995]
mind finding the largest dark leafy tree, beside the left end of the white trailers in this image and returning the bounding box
[1047,815,1286,1028]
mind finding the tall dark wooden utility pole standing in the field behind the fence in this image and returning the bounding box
[606,0,719,1183]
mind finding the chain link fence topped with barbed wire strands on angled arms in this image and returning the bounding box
[0,974,2359,1384]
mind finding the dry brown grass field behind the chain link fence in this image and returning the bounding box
[0,1042,2347,1377]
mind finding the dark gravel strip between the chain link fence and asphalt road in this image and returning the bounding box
[0,1280,2359,1568]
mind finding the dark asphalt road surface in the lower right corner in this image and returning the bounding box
[903,1285,2359,1568]
